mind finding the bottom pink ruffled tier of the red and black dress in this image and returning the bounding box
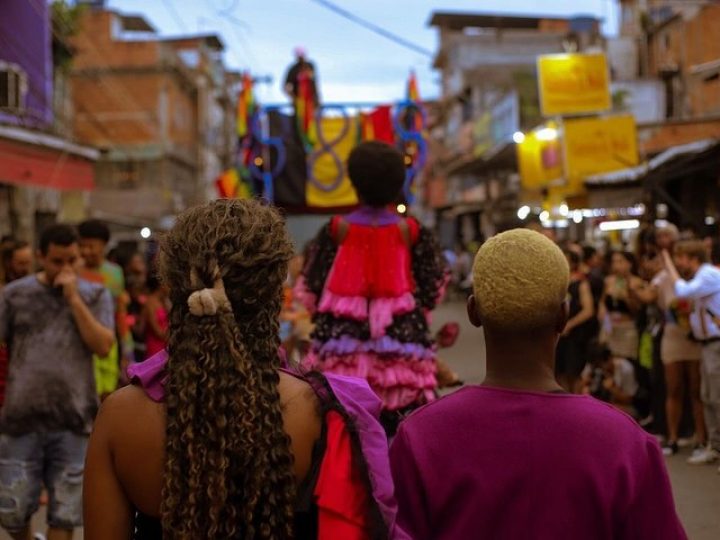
[303,352,437,410]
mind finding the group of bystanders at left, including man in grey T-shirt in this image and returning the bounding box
[0,220,167,540]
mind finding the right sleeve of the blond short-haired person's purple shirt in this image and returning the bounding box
[619,440,687,540]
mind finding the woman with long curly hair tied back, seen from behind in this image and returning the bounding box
[84,200,404,540]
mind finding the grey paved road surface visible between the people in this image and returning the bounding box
[0,302,720,540]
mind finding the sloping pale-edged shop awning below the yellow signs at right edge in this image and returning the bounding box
[585,139,720,188]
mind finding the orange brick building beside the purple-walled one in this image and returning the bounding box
[70,7,233,231]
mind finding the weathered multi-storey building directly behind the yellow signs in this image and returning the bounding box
[427,12,604,247]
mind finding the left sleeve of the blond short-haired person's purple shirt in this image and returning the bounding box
[390,426,432,540]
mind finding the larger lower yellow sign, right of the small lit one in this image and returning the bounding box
[563,115,638,189]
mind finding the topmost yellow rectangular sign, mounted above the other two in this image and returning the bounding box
[538,53,612,116]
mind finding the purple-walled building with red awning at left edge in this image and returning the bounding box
[0,0,98,242]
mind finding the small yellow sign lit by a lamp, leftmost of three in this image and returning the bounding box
[517,131,563,190]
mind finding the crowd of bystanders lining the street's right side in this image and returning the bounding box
[546,223,720,465]
